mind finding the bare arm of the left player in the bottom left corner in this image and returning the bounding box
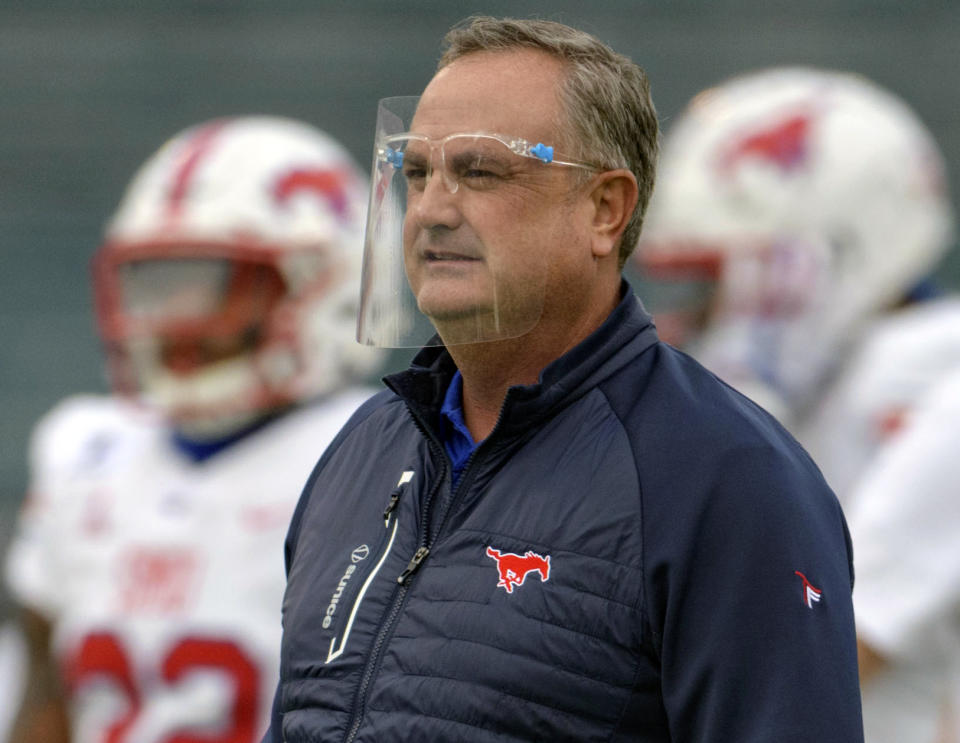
[10,608,70,743]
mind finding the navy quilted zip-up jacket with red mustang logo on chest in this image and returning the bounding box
[266,285,862,743]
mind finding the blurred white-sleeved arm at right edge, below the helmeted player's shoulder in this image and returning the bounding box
[849,375,960,689]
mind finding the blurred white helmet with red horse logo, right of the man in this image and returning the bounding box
[635,68,953,421]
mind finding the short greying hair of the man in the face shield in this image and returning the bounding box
[437,16,659,268]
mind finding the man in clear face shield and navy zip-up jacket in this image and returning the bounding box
[267,18,862,743]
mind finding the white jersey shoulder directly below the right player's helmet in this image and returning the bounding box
[796,298,960,506]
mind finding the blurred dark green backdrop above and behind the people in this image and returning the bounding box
[0,0,960,560]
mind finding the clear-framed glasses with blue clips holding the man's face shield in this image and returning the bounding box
[377,132,600,193]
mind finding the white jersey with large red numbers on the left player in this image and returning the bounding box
[7,390,372,743]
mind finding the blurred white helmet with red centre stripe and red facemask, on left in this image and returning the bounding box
[94,116,383,438]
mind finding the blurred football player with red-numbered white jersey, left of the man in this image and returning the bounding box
[6,116,383,743]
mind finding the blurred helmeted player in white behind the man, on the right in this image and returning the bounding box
[635,68,960,743]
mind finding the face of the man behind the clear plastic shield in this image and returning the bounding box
[403,50,589,343]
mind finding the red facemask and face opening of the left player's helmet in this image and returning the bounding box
[97,246,328,439]
